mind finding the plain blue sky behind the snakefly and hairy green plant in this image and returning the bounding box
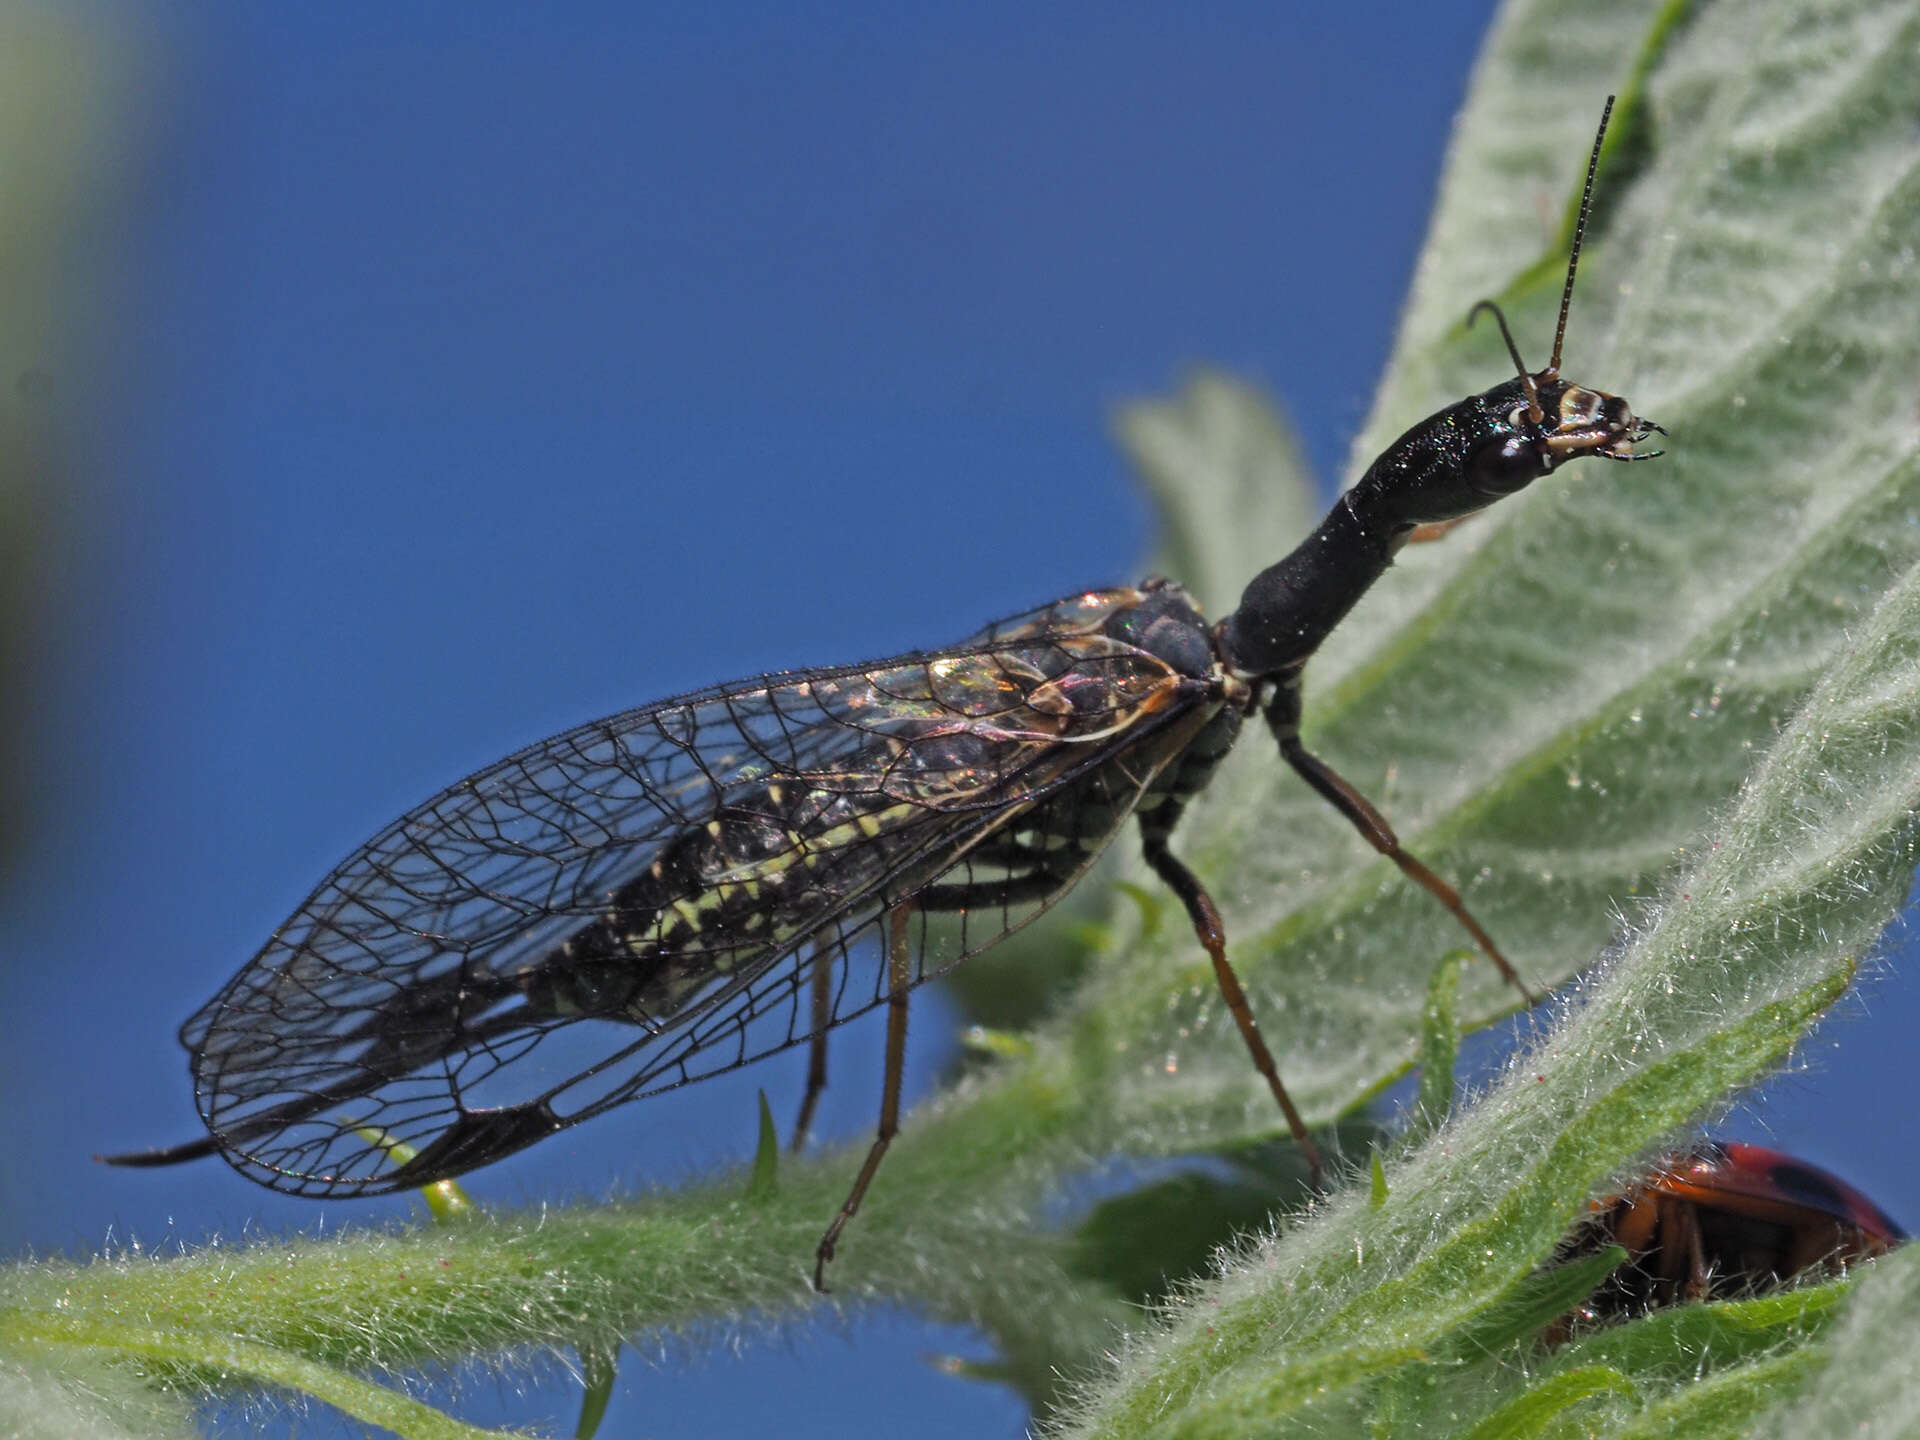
[0,4,1920,1440]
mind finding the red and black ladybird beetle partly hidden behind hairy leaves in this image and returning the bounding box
[1553,1140,1907,1338]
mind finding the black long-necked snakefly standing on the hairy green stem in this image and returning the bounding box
[111,100,1659,1288]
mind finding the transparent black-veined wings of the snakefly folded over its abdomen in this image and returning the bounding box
[180,589,1206,1194]
